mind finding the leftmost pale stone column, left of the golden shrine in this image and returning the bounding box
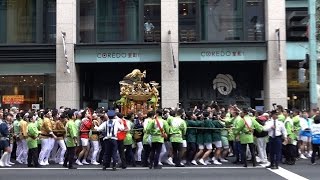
[56,0,80,108]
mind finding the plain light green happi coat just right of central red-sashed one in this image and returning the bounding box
[168,116,187,143]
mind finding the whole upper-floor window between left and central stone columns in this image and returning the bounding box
[78,0,161,43]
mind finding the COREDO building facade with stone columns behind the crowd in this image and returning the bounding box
[0,0,318,110]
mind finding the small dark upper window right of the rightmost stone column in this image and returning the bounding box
[286,8,308,41]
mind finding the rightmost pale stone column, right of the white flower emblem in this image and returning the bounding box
[264,0,288,110]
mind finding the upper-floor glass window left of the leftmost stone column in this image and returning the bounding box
[0,0,56,44]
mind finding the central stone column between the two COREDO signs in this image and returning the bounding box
[161,0,179,107]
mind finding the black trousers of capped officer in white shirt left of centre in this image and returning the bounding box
[103,139,118,168]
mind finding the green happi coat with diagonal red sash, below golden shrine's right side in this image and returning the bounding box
[146,117,169,143]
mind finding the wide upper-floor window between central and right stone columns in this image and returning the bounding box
[179,0,265,42]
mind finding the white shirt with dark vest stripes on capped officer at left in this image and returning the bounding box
[94,119,124,140]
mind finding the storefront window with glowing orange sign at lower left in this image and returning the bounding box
[0,75,55,110]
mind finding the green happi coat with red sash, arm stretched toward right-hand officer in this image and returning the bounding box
[234,115,263,144]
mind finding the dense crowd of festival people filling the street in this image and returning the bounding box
[0,105,320,170]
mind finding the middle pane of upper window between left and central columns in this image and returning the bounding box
[97,0,139,42]
